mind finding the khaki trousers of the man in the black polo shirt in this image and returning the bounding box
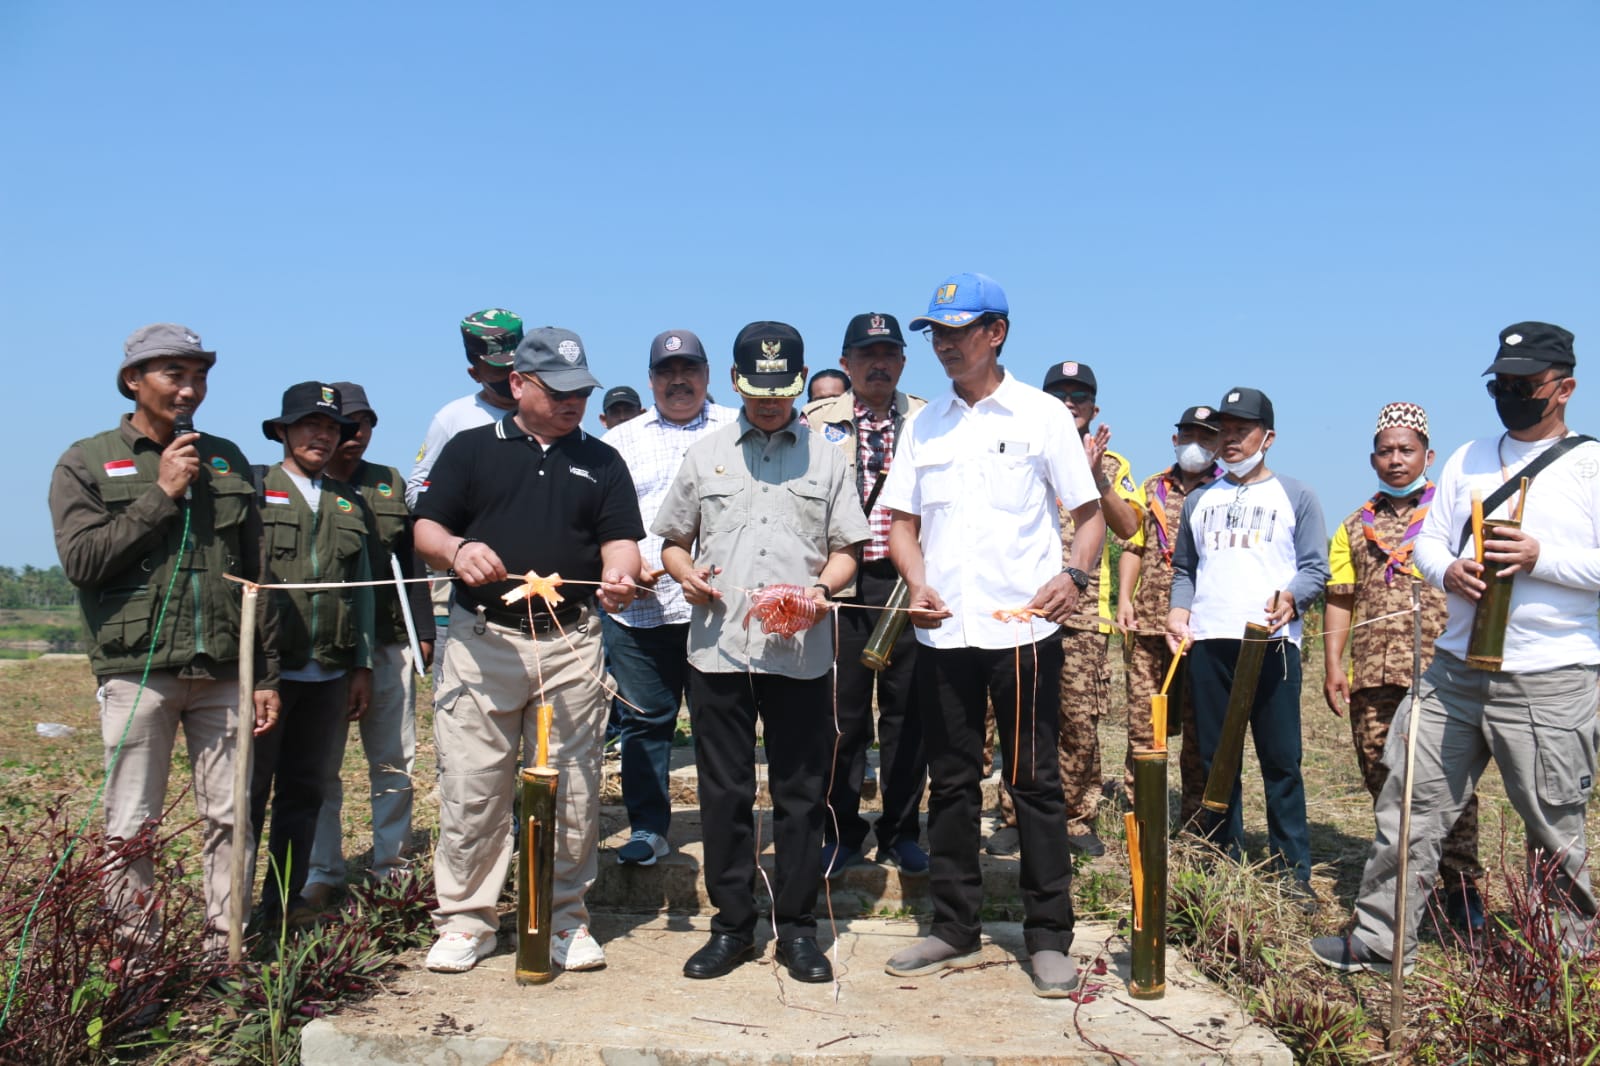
[434,607,608,933]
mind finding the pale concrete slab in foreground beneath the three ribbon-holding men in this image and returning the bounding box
[301,914,1293,1066]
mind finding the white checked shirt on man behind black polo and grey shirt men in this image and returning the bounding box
[600,400,739,629]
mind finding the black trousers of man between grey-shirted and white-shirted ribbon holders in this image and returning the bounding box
[822,560,928,852]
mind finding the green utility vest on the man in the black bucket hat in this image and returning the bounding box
[261,463,373,671]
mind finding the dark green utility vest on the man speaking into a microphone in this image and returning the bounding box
[78,429,254,677]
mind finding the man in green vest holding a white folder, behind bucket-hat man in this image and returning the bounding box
[301,381,434,909]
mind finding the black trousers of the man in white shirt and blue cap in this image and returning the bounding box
[917,637,1074,952]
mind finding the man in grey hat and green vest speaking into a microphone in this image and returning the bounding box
[50,322,278,954]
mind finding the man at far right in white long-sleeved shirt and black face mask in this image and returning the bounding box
[1310,322,1600,973]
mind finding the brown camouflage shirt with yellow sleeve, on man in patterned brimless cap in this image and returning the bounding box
[1328,491,1445,690]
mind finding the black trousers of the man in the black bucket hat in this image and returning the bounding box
[250,674,350,914]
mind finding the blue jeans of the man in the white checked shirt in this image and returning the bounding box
[600,615,690,836]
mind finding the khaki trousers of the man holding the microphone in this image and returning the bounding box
[98,671,238,952]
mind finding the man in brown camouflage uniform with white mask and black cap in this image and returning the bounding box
[1117,407,1216,826]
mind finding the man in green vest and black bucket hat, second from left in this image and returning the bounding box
[250,381,374,930]
